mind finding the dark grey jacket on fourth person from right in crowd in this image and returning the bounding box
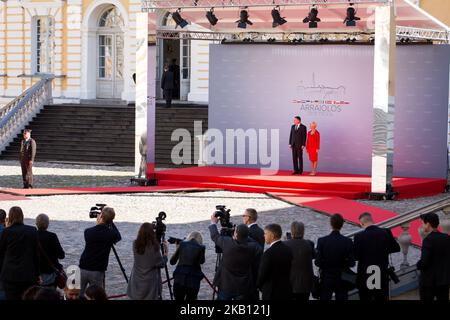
[284,239,315,293]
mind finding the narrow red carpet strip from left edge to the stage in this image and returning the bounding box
[0,186,204,197]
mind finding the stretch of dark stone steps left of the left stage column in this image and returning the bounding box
[0,104,135,166]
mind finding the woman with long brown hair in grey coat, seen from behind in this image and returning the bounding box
[127,222,167,300]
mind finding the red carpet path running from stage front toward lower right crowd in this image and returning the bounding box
[269,193,422,246]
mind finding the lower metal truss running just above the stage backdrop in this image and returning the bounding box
[153,26,450,43]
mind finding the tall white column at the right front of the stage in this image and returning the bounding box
[372,3,396,193]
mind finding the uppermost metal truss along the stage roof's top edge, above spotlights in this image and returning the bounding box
[141,0,391,12]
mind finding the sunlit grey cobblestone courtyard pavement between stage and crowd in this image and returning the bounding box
[0,161,448,299]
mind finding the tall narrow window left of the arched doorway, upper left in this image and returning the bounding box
[32,16,55,73]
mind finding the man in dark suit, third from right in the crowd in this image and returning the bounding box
[315,213,355,301]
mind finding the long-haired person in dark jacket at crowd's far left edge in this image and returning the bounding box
[0,207,40,300]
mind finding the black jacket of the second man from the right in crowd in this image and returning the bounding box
[354,225,400,286]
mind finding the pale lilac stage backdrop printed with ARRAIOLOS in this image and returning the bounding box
[209,45,450,177]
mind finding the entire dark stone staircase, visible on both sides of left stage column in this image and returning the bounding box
[0,101,208,168]
